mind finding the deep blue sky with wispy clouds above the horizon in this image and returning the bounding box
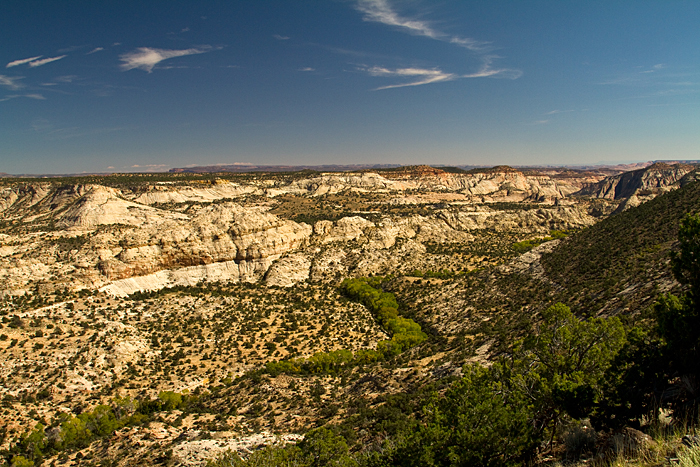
[0,0,700,173]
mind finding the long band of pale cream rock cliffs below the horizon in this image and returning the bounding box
[0,169,608,295]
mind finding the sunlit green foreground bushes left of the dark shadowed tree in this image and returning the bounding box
[205,297,624,467]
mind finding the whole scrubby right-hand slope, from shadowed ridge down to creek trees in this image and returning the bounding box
[391,177,700,364]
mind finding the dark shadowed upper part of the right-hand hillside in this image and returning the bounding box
[541,182,700,313]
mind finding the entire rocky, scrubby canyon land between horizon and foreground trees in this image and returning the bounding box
[0,167,700,466]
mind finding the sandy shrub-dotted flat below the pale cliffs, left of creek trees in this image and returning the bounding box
[0,284,386,450]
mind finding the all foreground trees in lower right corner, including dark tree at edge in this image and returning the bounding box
[348,216,700,466]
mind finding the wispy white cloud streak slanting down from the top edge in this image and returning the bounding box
[356,0,489,52]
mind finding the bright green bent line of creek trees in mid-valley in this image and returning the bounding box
[265,276,428,376]
